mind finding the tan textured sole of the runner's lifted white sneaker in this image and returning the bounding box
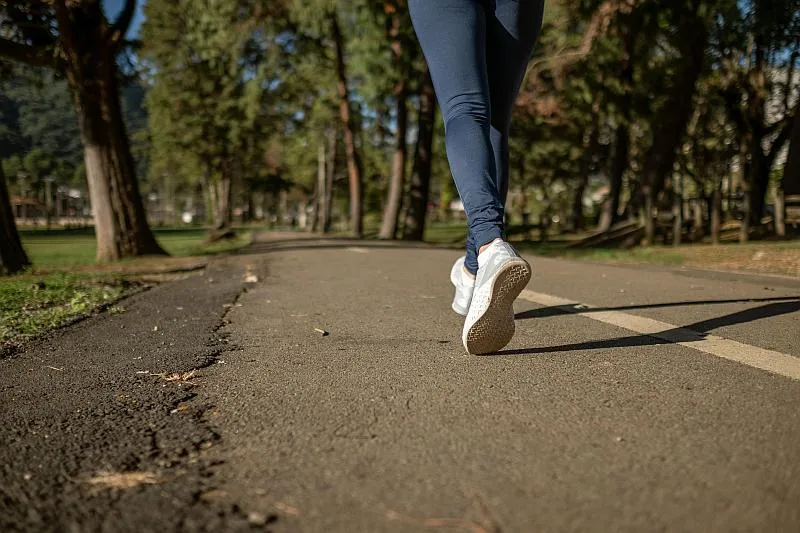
[464,260,531,355]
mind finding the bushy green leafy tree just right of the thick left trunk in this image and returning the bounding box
[142,0,294,237]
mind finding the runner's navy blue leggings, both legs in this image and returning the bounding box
[409,0,544,274]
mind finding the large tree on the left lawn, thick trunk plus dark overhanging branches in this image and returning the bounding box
[0,0,164,261]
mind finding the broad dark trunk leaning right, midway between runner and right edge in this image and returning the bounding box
[642,14,708,245]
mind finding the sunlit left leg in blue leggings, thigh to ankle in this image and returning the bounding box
[409,0,503,274]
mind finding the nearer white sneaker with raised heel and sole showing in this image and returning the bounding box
[461,239,531,354]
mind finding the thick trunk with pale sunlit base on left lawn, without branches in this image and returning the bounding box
[56,2,165,261]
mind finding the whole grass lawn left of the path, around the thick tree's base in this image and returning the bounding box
[0,224,253,356]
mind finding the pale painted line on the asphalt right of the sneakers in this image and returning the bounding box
[520,290,800,380]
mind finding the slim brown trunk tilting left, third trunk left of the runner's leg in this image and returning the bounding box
[329,11,364,239]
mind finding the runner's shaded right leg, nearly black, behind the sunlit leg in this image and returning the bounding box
[486,0,544,207]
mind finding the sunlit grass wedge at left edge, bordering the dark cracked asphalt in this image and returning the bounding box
[0,272,139,355]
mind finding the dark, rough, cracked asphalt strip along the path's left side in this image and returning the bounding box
[0,261,255,533]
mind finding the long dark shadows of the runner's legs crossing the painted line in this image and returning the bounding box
[500,297,800,356]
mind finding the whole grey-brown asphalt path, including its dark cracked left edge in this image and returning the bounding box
[0,237,800,533]
